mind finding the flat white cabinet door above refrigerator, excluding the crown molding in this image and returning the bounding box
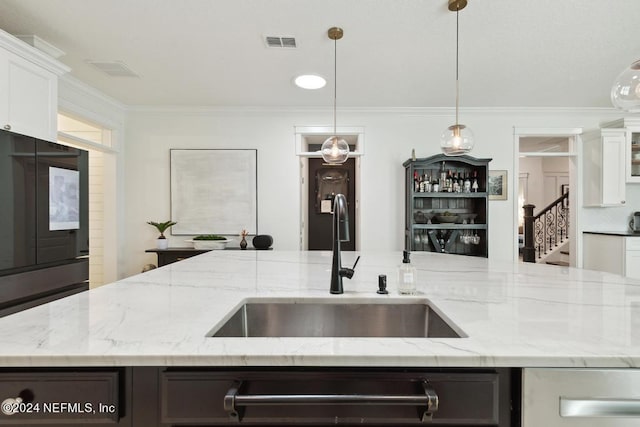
[0,49,58,141]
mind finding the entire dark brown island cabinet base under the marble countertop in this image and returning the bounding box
[0,366,521,427]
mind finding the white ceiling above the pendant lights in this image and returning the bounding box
[0,0,640,108]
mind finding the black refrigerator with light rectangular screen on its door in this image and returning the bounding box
[0,130,89,316]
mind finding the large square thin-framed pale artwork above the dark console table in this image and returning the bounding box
[170,149,258,236]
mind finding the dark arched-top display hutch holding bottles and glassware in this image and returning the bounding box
[403,154,491,257]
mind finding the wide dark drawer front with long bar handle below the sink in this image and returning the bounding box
[160,368,520,427]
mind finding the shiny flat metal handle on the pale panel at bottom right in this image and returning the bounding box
[560,396,640,417]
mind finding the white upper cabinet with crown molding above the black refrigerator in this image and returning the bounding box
[0,31,69,141]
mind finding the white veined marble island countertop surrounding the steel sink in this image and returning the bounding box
[0,251,640,367]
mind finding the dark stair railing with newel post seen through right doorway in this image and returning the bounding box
[522,192,569,262]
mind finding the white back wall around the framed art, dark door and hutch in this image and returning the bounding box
[123,108,640,275]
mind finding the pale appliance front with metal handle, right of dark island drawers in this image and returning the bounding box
[522,368,640,427]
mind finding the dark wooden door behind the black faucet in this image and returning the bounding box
[307,158,356,251]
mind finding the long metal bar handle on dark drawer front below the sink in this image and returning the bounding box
[224,381,439,423]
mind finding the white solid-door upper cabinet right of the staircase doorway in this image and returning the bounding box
[582,129,627,206]
